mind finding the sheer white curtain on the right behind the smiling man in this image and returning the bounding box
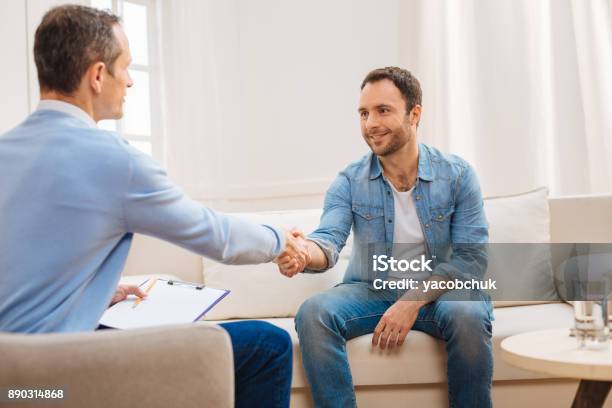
[401,0,612,195]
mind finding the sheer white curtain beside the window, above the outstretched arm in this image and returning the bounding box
[157,0,230,198]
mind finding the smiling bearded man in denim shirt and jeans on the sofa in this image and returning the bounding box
[279,67,493,408]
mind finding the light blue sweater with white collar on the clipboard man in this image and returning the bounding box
[0,101,284,333]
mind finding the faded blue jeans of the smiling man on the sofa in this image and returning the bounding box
[295,283,493,408]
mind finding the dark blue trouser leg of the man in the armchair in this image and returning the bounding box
[219,320,293,408]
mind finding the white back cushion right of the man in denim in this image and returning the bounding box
[484,188,558,307]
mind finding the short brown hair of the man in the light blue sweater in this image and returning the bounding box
[34,5,121,95]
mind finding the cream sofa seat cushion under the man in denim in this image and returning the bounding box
[212,303,574,388]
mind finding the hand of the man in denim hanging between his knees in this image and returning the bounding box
[372,300,425,350]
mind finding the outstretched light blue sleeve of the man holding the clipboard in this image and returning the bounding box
[123,148,284,264]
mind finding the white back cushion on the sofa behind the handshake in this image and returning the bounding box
[204,209,352,320]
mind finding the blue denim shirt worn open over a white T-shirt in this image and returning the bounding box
[305,143,489,282]
